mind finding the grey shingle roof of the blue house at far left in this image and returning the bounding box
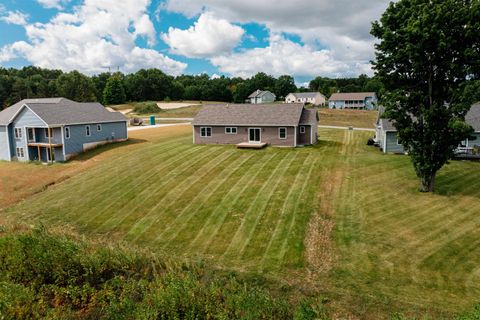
[0,98,127,126]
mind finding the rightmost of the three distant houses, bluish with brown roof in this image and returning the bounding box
[328,92,378,110]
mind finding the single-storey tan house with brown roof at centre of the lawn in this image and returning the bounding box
[193,103,318,147]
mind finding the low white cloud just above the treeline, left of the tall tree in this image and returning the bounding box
[210,34,371,77]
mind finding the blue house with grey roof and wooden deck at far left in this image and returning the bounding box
[0,98,128,162]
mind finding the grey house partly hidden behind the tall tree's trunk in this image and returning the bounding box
[374,103,480,153]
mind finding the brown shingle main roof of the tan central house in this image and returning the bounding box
[193,103,304,126]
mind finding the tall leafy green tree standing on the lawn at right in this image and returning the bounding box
[371,0,480,192]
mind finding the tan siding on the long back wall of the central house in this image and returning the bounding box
[194,125,295,147]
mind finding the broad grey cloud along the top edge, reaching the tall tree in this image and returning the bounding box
[162,0,390,74]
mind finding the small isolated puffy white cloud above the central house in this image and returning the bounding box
[162,12,244,58]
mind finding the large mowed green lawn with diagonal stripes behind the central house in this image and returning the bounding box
[2,126,480,319]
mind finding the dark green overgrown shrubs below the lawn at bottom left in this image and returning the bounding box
[0,229,322,319]
